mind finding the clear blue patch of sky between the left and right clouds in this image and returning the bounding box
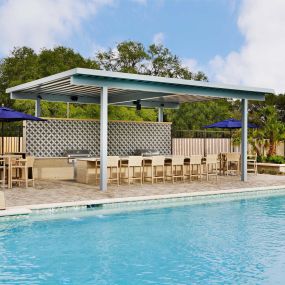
[65,0,243,65]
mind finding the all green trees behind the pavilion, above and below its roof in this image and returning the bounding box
[0,41,285,145]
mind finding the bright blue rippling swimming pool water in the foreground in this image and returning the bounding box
[0,192,285,285]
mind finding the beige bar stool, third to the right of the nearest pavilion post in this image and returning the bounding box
[143,155,165,184]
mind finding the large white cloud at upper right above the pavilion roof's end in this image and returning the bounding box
[210,0,285,93]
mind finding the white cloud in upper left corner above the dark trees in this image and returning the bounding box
[0,0,112,54]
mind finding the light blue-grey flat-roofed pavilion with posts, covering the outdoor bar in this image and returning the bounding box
[6,68,274,191]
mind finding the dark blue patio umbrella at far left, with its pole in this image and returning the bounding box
[0,107,45,154]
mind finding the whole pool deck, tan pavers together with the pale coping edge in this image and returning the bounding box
[0,174,285,216]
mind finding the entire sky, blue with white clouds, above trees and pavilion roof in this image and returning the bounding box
[0,0,285,93]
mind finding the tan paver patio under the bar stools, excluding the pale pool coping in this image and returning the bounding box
[4,174,285,207]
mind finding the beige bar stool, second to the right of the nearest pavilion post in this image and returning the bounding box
[120,156,143,184]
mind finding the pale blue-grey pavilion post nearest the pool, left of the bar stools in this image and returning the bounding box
[100,86,108,191]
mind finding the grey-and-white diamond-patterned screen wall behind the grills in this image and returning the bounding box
[25,119,171,157]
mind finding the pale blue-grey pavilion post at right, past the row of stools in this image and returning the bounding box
[241,99,248,181]
